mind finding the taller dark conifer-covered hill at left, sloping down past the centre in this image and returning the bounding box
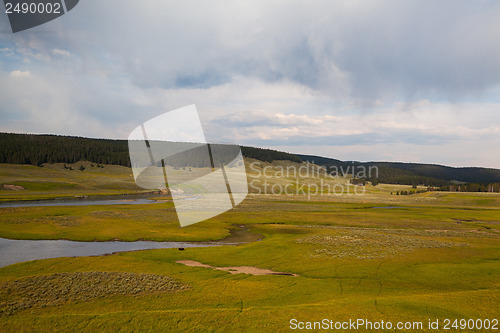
[0,133,302,166]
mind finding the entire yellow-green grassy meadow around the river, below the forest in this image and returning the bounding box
[0,162,500,332]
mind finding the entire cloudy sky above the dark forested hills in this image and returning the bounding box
[0,0,500,168]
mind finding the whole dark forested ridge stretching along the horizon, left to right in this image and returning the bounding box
[0,133,500,190]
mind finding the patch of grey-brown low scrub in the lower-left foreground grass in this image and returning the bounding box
[0,272,189,316]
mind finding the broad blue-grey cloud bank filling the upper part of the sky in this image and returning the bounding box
[4,0,500,101]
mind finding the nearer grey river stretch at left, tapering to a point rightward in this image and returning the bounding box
[0,238,213,267]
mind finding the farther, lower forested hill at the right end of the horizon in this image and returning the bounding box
[297,155,500,186]
